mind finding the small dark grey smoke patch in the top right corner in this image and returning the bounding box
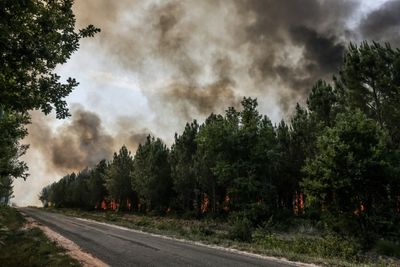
[360,0,400,46]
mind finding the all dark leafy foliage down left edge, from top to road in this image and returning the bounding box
[0,0,100,202]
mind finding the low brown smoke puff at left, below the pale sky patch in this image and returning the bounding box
[27,107,150,173]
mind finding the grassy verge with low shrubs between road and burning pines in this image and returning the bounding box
[41,208,400,267]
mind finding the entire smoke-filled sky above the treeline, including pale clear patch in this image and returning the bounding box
[13,0,400,205]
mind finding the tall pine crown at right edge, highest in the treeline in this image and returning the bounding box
[337,42,400,143]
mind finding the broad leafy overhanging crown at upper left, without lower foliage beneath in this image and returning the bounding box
[0,0,99,118]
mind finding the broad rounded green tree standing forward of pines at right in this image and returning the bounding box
[302,111,395,239]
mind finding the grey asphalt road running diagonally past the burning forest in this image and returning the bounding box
[20,208,300,267]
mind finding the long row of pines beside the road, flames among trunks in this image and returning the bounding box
[40,42,400,245]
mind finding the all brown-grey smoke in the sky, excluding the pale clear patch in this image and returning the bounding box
[30,0,400,174]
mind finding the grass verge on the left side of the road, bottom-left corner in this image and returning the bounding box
[0,205,81,267]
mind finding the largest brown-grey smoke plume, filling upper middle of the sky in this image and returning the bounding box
[69,0,366,118]
